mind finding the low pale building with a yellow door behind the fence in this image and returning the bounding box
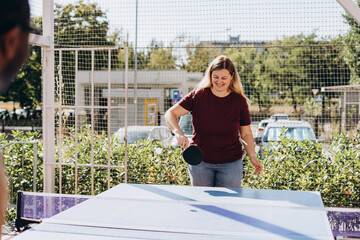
[77,70,203,132]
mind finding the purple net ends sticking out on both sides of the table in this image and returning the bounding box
[15,191,360,238]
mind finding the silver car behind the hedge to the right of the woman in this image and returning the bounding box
[258,120,324,159]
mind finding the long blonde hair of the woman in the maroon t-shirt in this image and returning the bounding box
[195,55,250,105]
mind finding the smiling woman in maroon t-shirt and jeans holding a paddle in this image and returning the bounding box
[165,56,263,188]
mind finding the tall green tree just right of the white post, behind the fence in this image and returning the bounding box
[54,0,123,105]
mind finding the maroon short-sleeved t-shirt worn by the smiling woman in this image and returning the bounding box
[179,88,251,164]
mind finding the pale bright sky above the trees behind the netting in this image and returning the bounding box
[30,0,348,47]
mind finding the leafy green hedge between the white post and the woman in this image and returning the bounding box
[56,126,189,195]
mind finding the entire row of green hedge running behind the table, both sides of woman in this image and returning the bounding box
[0,125,360,223]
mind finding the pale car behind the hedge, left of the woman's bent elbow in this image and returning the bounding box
[114,126,172,147]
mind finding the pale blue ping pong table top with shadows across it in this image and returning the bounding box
[12,184,334,240]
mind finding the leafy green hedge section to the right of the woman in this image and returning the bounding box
[243,134,360,207]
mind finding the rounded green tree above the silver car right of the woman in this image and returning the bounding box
[265,34,350,111]
